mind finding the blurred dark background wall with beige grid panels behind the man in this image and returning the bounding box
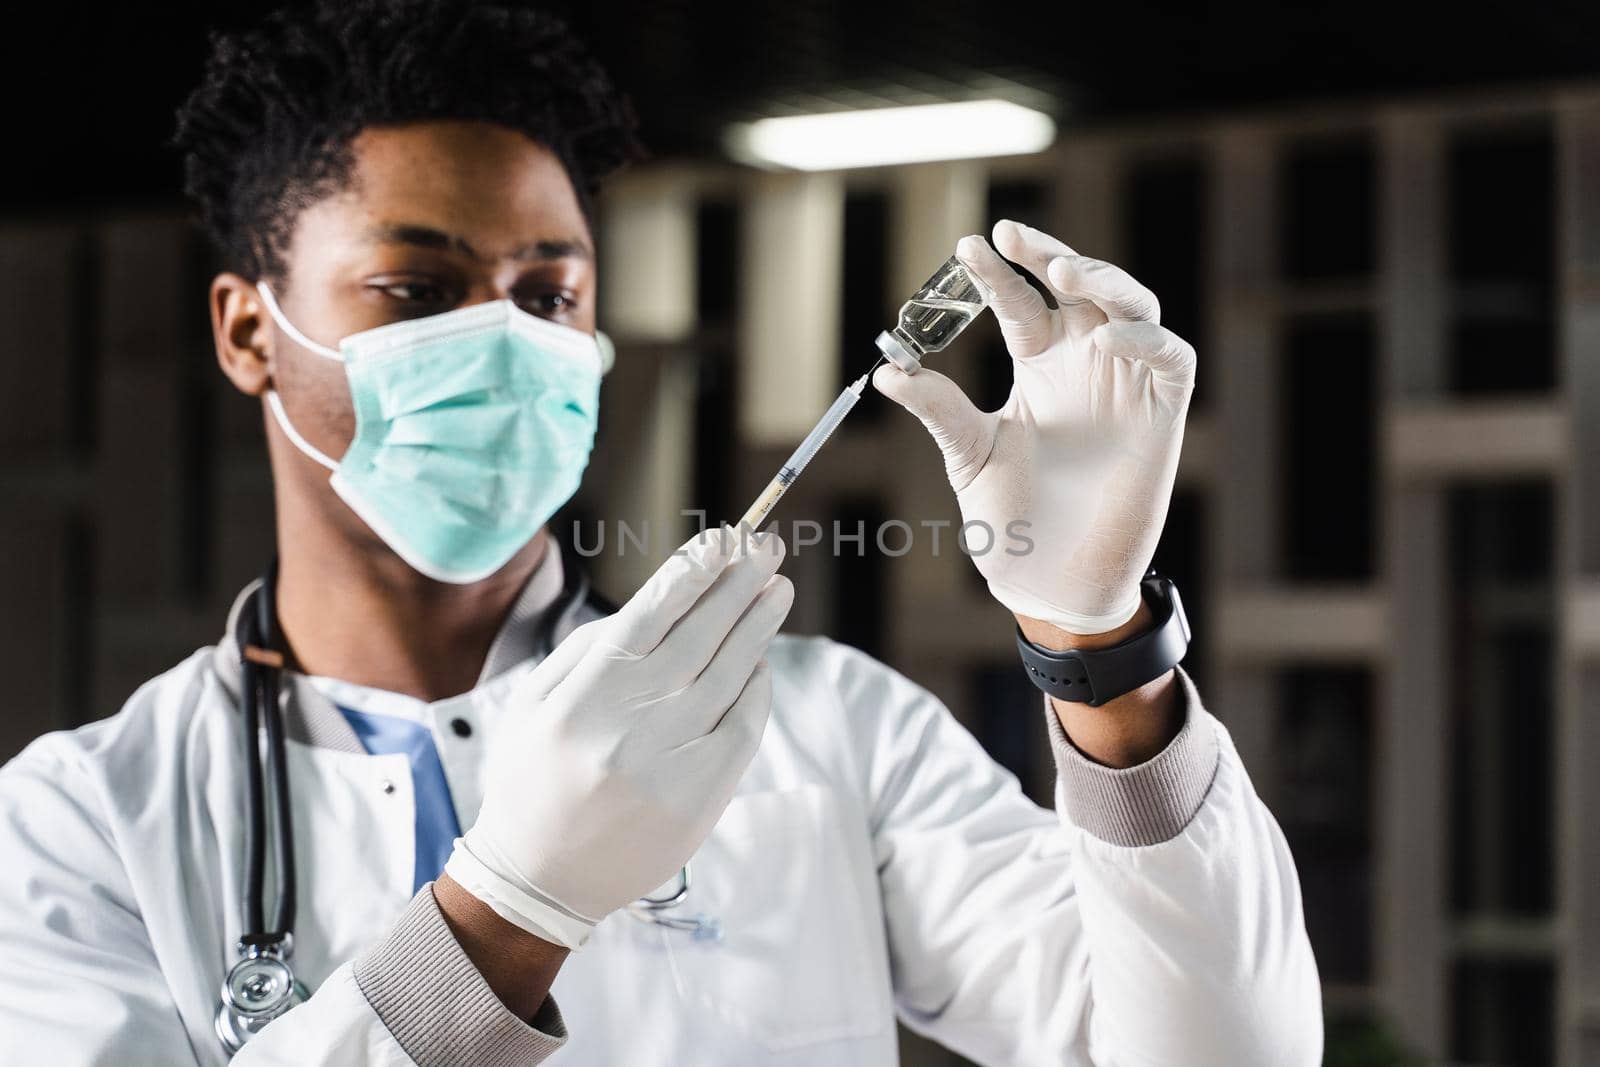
[0,3,1600,1067]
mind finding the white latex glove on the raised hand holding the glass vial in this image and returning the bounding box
[872,219,1195,633]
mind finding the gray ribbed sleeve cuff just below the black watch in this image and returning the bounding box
[1045,670,1221,848]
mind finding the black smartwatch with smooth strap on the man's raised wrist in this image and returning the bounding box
[1016,573,1190,707]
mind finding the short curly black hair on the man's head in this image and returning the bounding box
[173,0,643,283]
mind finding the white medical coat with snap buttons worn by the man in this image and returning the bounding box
[0,563,1322,1067]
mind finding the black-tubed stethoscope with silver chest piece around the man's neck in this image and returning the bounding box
[216,545,722,1056]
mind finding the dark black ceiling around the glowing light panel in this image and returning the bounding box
[0,0,1600,216]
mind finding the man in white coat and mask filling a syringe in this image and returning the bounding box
[0,0,1322,1067]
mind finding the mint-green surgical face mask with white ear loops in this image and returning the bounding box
[258,282,611,584]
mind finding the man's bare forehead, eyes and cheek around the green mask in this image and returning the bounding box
[235,122,595,470]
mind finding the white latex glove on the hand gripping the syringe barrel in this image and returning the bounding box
[445,528,794,949]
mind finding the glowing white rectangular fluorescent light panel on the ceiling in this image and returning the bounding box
[726,99,1056,171]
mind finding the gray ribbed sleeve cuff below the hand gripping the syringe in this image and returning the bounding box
[355,883,566,1067]
